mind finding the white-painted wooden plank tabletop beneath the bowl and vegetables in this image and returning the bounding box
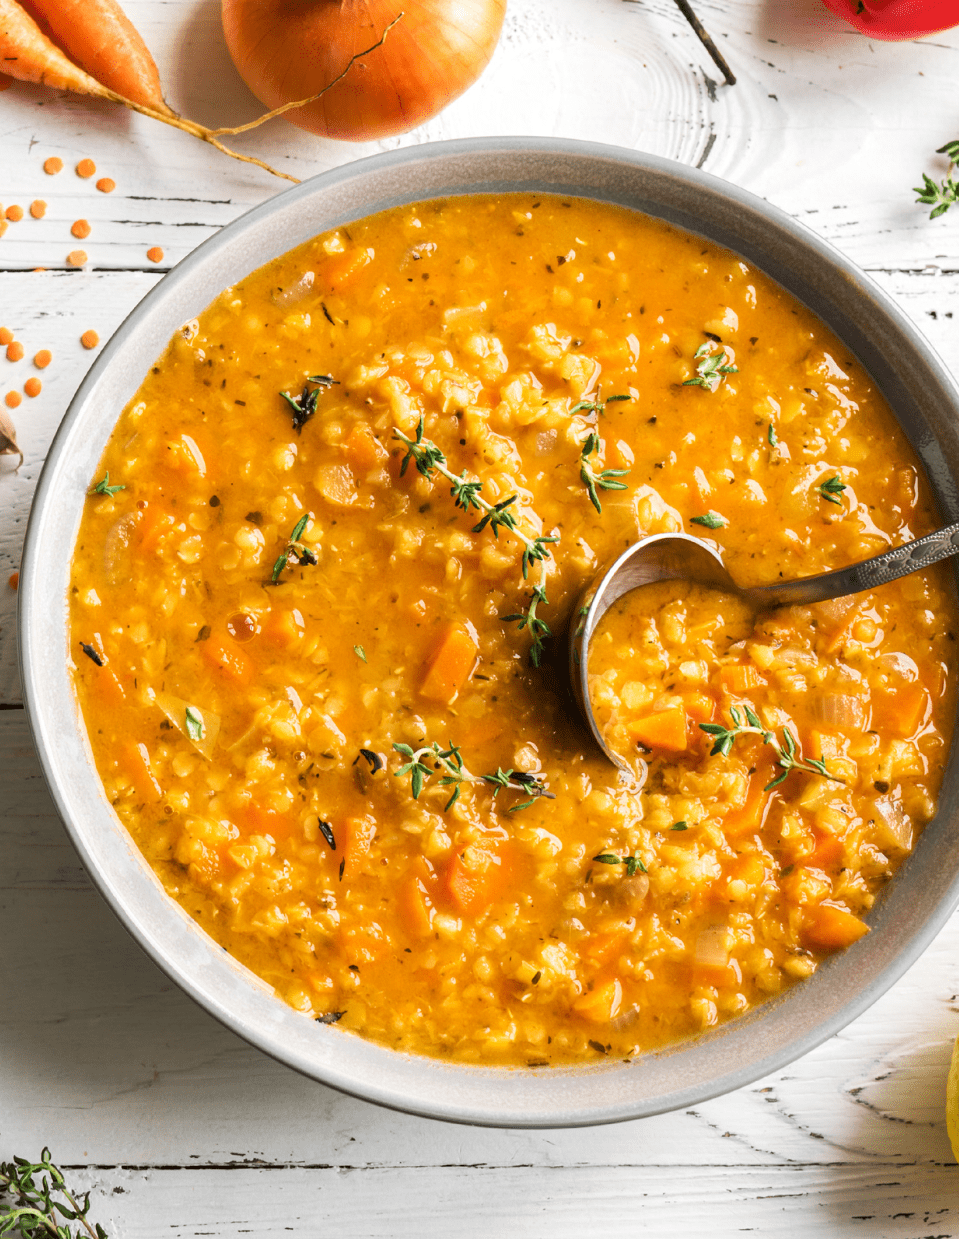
[0,0,959,1239]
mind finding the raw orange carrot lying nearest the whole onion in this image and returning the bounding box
[21,0,170,113]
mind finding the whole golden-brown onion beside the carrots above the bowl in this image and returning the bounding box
[222,0,506,141]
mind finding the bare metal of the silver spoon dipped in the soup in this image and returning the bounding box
[569,524,959,769]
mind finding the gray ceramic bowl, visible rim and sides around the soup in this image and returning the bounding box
[20,139,959,1127]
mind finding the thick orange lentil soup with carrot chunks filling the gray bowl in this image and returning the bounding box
[71,196,957,1063]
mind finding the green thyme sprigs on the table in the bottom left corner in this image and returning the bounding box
[0,1149,107,1239]
